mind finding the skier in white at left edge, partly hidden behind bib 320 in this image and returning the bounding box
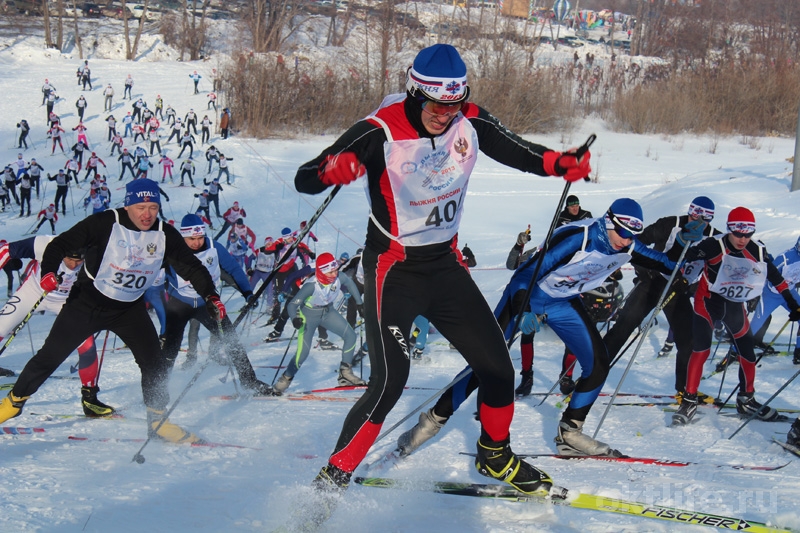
[0,236,114,417]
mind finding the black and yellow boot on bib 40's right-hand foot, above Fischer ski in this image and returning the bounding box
[475,436,553,496]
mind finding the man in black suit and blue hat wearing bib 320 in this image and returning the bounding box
[0,179,225,442]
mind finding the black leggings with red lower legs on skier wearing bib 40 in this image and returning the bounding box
[331,248,514,471]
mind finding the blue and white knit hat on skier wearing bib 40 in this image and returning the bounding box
[406,44,469,104]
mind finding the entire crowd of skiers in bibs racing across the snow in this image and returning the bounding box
[0,44,800,521]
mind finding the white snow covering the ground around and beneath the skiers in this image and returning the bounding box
[0,32,800,532]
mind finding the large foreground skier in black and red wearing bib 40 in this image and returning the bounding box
[295,44,591,494]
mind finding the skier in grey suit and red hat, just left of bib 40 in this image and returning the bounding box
[275,252,367,394]
